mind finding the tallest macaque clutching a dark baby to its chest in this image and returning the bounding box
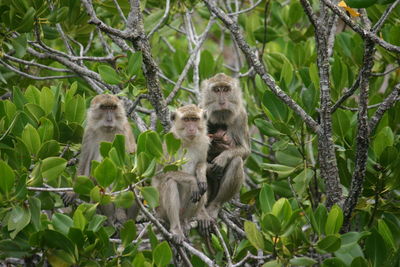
[199,73,250,224]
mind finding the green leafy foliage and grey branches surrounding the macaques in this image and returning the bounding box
[0,0,400,266]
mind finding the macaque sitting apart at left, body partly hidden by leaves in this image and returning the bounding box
[63,95,137,228]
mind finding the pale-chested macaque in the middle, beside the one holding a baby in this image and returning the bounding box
[152,105,209,244]
